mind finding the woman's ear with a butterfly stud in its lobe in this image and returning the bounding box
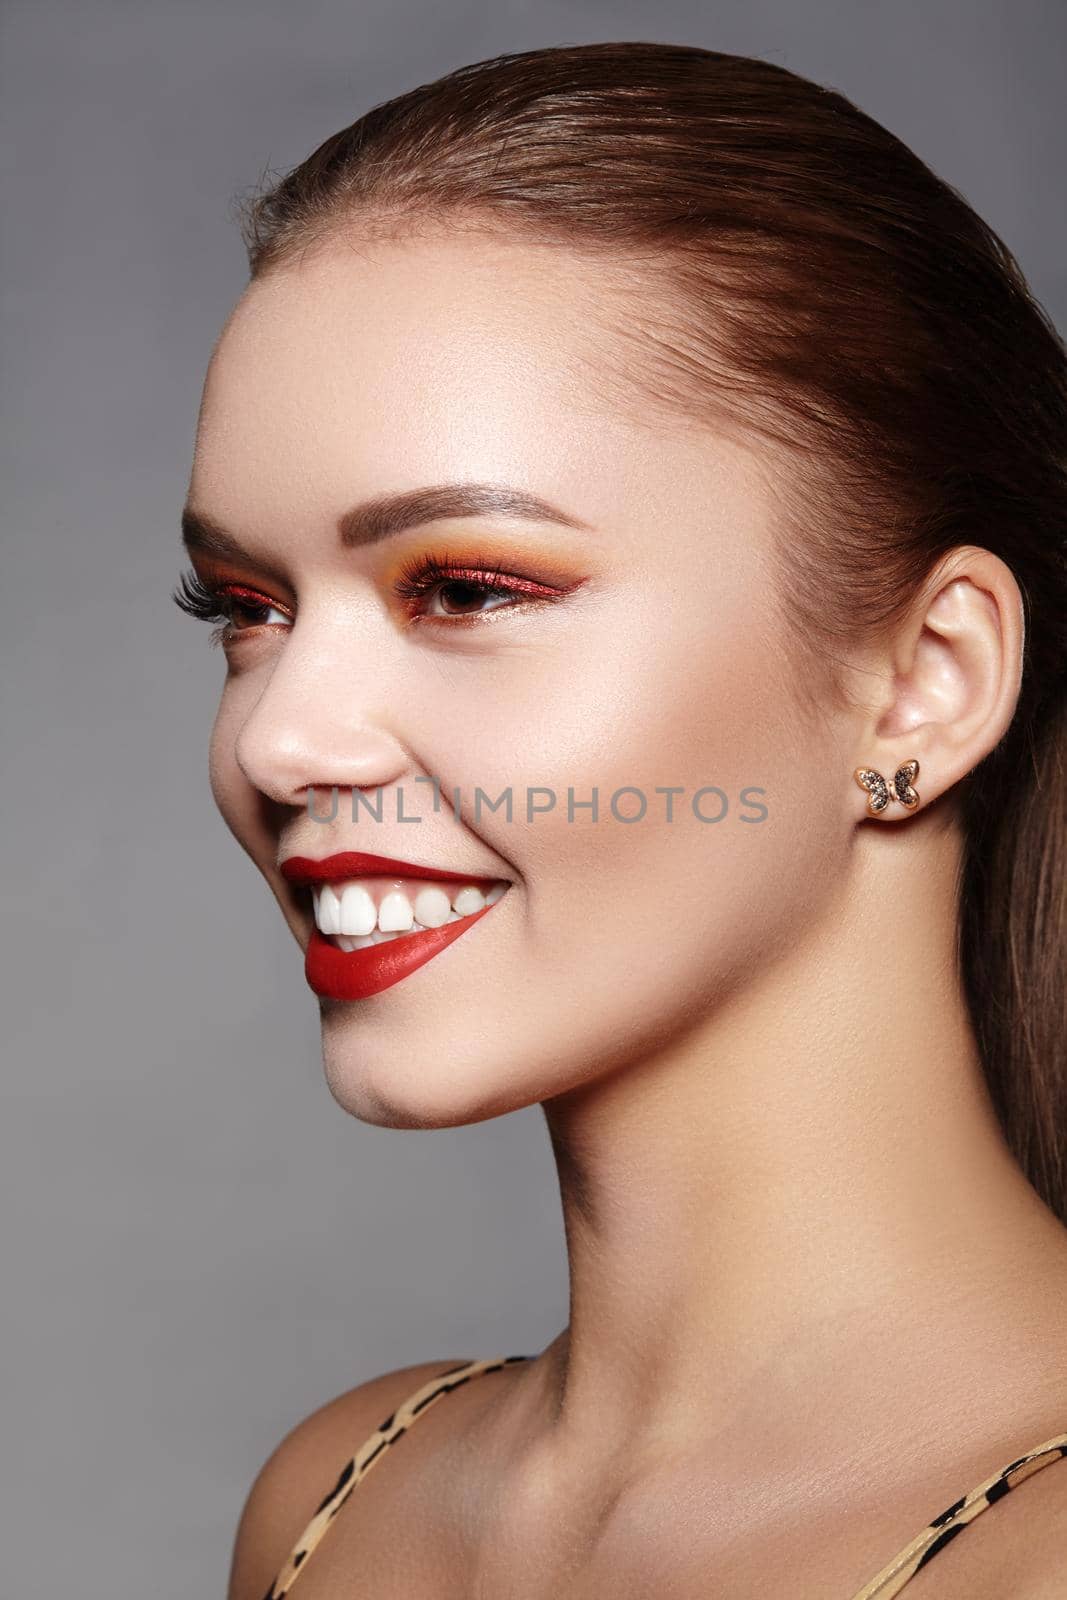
[854,546,1025,821]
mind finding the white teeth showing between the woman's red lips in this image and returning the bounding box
[310,874,510,952]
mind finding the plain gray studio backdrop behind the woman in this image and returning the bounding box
[0,0,1067,1600]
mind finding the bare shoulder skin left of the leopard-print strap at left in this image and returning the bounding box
[227,1357,469,1600]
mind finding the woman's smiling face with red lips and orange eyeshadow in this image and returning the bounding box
[189,235,862,1126]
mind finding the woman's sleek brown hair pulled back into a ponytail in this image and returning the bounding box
[238,40,1067,1221]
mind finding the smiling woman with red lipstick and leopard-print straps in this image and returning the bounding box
[176,42,1067,1600]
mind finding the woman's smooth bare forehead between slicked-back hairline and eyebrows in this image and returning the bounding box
[190,234,771,556]
